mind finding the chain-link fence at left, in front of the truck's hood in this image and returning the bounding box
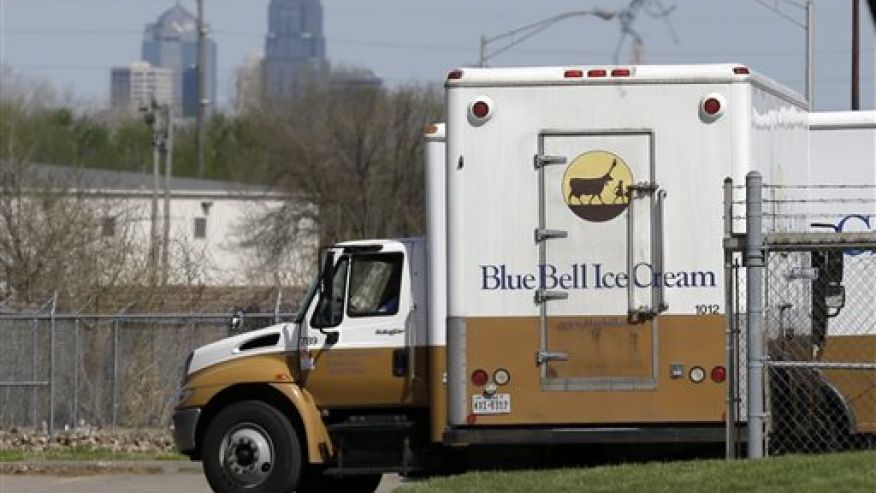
[0,310,294,432]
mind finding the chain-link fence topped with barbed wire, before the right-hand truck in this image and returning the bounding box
[725,175,876,457]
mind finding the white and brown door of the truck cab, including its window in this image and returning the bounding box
[299,248,414,407]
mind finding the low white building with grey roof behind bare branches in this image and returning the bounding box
[23,164,318,286]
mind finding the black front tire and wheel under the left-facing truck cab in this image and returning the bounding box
[201,401,304,493]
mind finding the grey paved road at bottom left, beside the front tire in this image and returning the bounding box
[0,472,401,493]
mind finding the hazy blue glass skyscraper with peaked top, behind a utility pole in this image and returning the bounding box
[142,4,216,118]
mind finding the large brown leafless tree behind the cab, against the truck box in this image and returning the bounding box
[241,71,441,256]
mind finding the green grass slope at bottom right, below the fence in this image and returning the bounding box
[396,452,876,493]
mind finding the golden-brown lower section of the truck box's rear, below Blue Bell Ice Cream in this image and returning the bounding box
[465,315,726,425]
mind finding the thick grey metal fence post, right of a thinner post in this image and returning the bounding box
[745,171,766,459]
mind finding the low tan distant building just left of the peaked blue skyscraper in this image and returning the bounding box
[110,62,178,114]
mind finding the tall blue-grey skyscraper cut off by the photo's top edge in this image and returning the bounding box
[264,0,327,101]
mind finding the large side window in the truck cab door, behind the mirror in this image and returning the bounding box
[347,254,403,317]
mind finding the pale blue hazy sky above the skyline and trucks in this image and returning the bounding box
[0,0,876,110]
